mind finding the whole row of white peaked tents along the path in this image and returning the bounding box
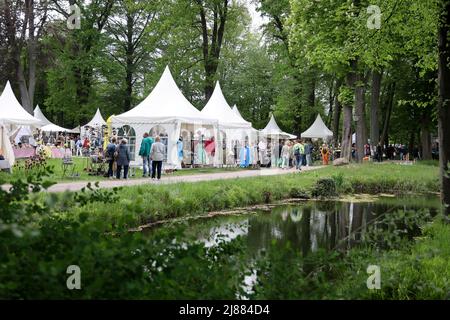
[0,67,333,168]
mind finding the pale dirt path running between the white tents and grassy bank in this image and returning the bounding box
[2,166,323,192]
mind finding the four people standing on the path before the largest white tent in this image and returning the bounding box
[105,133,166,181]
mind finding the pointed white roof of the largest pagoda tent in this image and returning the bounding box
[112,66,217,124]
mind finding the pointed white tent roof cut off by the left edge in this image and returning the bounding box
[0,81,41,125]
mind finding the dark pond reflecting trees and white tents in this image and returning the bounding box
[148,196,440,299]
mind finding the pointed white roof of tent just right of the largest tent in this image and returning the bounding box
[202,82,252,129]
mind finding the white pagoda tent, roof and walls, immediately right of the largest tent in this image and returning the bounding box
[202,82,257,165]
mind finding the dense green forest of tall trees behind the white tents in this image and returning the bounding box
[0,0,440,159]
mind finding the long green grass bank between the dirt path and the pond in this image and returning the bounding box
[59,164,439,229]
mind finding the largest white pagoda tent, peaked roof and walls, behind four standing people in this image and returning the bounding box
[111,67,217,168]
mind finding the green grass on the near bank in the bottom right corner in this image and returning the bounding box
[326,218,450,300]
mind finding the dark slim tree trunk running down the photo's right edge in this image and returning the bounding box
[438,0,450,221]
